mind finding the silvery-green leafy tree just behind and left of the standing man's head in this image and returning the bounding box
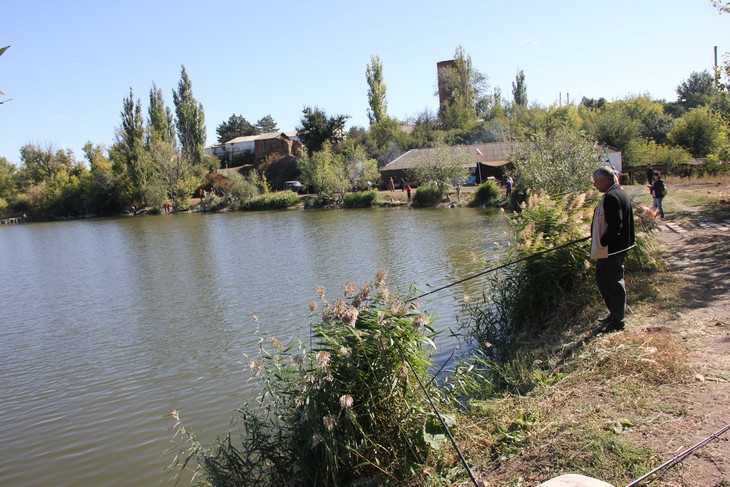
[510,130,600,195]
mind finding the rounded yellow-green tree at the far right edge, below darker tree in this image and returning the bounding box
[669,106,728,157]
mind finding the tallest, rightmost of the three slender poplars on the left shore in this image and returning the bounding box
[172,66,205,166]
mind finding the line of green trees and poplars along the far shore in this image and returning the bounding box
[0,34,730,218]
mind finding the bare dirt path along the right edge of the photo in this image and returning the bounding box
[620,218,730,487]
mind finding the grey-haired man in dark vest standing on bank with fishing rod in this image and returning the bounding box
[591,166,635,332]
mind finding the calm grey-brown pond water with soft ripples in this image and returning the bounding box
[0,208,507,486]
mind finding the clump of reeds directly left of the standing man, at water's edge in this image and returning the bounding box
[464,193,595,364]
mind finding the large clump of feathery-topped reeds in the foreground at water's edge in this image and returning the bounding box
[174,271,440,487]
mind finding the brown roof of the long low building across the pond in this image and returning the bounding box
[381,142,517,171]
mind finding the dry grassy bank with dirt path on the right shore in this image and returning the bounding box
[426,178,730,486]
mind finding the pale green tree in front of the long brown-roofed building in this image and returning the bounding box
[409,146,474,194]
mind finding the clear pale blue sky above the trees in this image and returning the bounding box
[0,0,730,162]
